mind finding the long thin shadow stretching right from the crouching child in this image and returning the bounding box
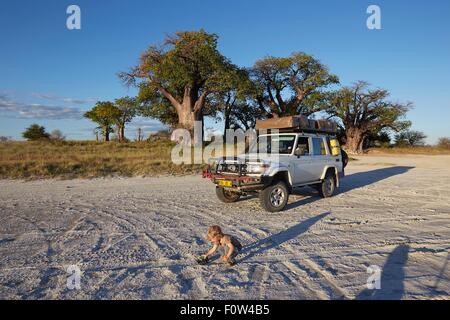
[238,212,330,262]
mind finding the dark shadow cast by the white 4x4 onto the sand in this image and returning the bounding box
[286,166,414,210]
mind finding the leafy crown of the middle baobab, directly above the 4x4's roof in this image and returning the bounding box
[252,52,339,116]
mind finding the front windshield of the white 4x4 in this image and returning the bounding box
[248,135,295,154]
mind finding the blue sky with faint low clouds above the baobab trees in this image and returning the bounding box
[0,0,450,143]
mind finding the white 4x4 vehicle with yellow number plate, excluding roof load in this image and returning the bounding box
[203,132,348,212]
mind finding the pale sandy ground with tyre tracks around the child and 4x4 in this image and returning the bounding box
[0,156,450,299]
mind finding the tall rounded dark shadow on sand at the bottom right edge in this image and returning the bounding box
[355,244,409,300]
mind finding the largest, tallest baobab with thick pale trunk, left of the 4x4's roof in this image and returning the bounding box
[119,30,234,127]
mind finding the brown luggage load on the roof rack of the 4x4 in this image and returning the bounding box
[256,115,337,134]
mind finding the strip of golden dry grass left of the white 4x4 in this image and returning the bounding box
[0,141,202,179]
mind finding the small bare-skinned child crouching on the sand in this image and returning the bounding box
[197,226,242,265]
